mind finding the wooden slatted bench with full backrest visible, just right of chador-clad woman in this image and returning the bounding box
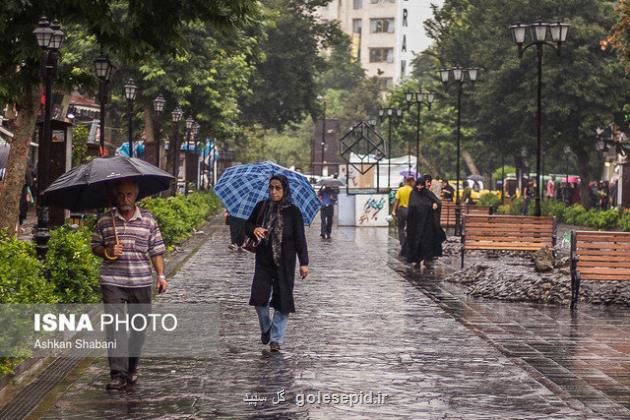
[461,214,556,268]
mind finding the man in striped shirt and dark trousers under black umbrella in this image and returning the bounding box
[92,181,168,389]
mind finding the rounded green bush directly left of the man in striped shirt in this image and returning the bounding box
[44,226,101,303]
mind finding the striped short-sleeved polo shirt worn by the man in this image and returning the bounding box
[92,206,166,287]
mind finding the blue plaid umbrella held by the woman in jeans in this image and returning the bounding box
[214,162,320,225]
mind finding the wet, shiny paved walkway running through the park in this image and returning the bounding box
[27,221,630,419]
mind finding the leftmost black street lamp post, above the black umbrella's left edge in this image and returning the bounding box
[33,16,65,258]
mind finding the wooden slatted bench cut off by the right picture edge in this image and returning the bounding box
[571,231,630,308]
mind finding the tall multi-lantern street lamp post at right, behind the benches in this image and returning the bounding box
[510,21,569,216]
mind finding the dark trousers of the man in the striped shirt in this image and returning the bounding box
[101,285,151,378]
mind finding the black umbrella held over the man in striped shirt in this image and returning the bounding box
[42,156,174,211]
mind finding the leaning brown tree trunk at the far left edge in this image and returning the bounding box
[0,88,39,235]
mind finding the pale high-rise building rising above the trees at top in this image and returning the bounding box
[317,0,443,88]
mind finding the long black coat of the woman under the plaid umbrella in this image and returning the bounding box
[245,201,308,313]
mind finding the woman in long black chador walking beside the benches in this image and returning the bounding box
[407,178,446,268]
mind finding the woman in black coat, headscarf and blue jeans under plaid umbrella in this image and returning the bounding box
[245,175,308,351]
